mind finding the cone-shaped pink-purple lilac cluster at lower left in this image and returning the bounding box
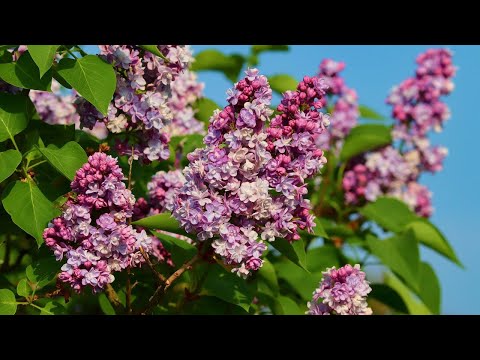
[43,153,169,292]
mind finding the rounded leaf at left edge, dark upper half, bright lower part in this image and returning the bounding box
[0,93,35,142]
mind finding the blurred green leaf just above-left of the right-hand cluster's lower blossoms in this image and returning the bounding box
[340,124,392,161]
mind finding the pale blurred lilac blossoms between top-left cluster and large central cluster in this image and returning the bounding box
[164,70,205,136]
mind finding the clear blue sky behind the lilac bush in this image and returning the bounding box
[84,45,480,314]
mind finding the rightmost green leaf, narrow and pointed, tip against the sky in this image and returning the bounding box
[406,219,463,267]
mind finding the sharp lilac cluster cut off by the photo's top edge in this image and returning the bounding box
[75,45,192,163]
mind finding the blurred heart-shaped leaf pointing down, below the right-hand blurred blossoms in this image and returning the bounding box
[367,231,420,291]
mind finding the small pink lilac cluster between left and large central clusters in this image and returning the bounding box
[133,170,185,219]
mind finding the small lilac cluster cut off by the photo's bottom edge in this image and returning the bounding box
[306,264,372,315]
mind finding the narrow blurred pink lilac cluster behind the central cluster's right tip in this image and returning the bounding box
[317,59,360,151]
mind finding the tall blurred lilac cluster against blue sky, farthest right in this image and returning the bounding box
[343,49,455,217]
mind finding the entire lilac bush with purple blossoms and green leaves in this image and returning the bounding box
[0,45,462,315]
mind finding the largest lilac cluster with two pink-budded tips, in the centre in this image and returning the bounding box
[173,69,329,277]
